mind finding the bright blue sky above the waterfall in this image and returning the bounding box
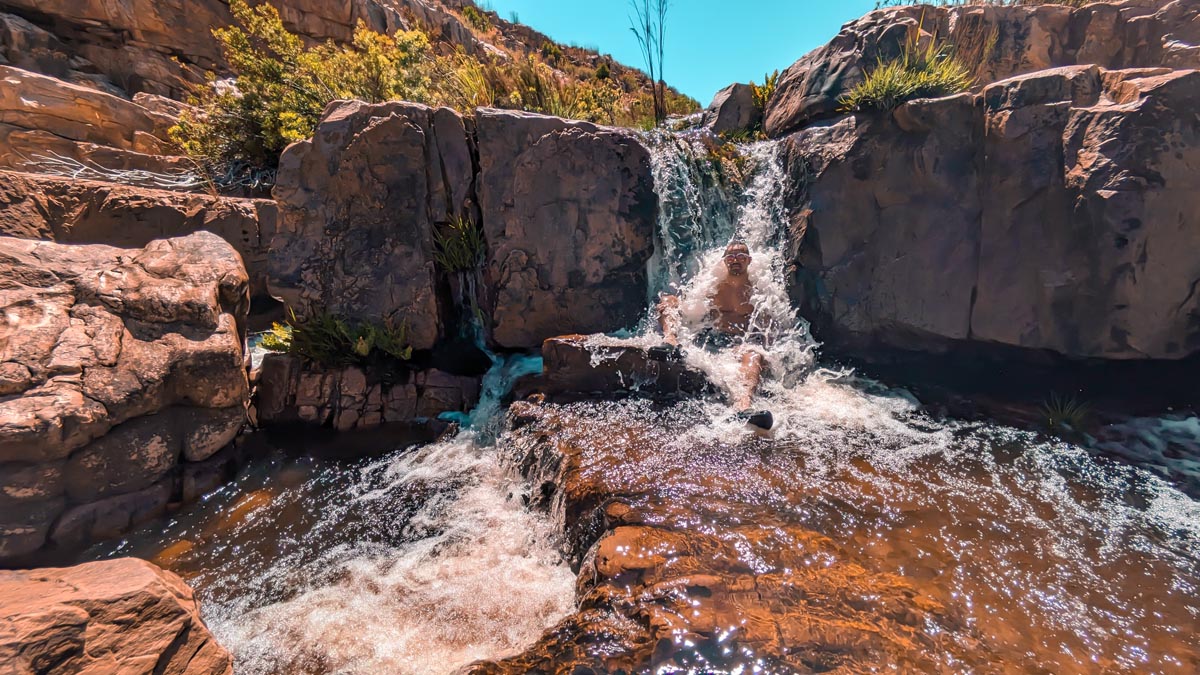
[476,0,875,104]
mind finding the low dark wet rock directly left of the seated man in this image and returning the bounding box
[539,335,713,400]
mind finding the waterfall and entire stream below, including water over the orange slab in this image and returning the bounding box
[89,137,1200,674]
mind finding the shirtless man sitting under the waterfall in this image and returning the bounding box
[659,239,774,430]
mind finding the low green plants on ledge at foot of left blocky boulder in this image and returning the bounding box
[262,312,413,368]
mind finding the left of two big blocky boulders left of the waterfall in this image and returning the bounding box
[269,102,474,350]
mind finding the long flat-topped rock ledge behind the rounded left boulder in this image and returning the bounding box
[0,171,277,303]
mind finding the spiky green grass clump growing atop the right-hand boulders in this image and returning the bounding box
[840,31,974,112]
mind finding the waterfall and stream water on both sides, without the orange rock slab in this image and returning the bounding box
[84,130,1200,675]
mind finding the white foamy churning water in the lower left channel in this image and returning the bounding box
[205,432,575,675]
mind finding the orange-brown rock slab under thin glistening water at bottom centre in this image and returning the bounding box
[469,404,958,674]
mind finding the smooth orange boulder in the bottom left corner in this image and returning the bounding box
[0,558,233,675]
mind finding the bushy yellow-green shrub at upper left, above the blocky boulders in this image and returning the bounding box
[170,0,430,168]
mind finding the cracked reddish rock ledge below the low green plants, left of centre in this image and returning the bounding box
[254,354,480,431]
